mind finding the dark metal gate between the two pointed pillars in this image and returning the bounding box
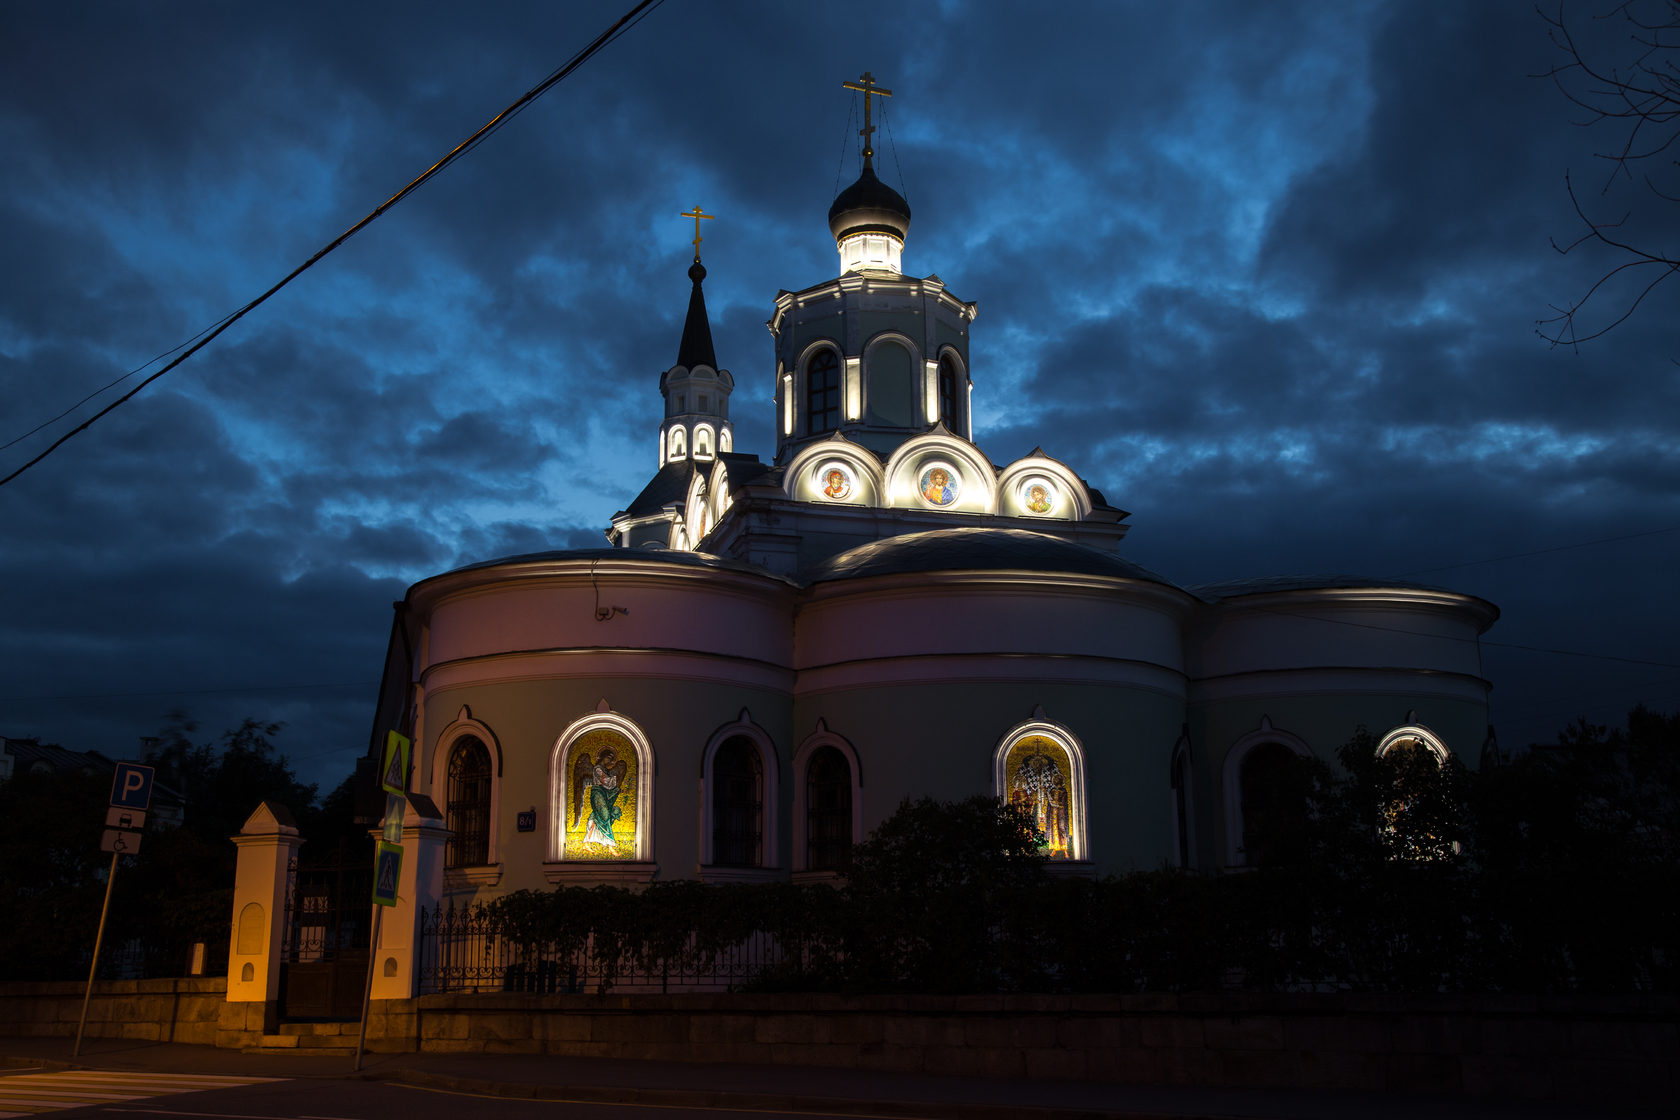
[279,843,373,1019]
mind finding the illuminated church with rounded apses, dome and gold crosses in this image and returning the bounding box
[367,74,1499,902]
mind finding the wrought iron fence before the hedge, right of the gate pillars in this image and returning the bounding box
[420,903,788,996]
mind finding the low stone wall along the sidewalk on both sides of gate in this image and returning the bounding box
[0,979,1680,1107]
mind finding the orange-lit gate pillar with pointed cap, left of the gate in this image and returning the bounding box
[218,801,302,1044]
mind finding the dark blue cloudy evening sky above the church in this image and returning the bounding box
[0,0,1680,782]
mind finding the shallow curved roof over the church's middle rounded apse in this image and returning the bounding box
[808,526,1173,588]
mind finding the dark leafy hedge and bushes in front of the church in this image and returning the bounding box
[470,709,1680,992]
